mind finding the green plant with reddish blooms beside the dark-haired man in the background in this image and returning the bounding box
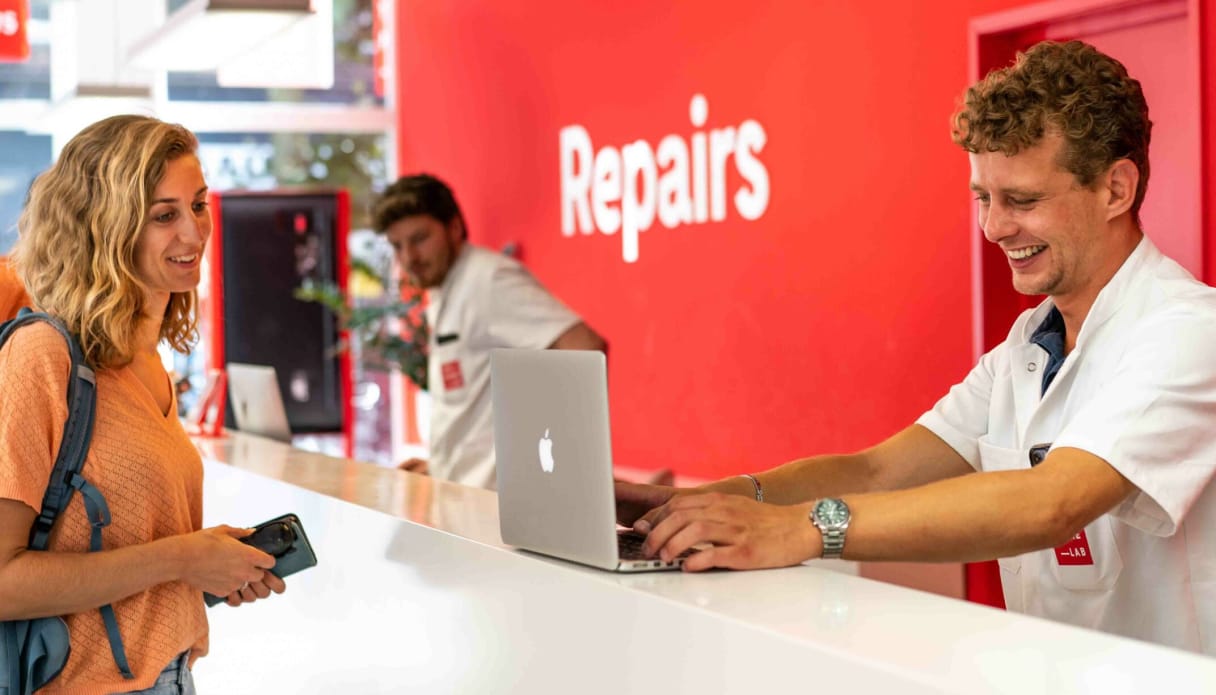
[294,275,429,390]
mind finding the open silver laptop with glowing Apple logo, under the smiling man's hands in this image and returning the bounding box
[490,350,683,572]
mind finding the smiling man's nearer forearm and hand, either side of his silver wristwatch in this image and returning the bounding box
[644,447,1136,571]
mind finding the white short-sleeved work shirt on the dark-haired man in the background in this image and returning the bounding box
[427,243,580,490]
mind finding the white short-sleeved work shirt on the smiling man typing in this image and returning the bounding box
[918,237,1216,655]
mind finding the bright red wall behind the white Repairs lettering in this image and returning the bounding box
[398,0,1089,478]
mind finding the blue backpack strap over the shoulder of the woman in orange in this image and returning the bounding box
[0,309,135,679]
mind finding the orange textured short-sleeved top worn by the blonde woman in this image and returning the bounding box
[0,323,207,695]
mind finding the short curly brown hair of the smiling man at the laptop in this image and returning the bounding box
[951,41,1153,224]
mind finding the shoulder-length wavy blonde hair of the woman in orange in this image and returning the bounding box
[12,115,198,368]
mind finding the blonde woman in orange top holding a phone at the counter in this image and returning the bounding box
[0,115,283,695]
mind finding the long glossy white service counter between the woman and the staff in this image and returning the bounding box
[195,434,1216,695]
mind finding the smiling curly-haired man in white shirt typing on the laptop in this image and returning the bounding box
[618,41,1216,654]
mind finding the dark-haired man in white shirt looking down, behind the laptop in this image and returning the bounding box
[373,174,606,490]
